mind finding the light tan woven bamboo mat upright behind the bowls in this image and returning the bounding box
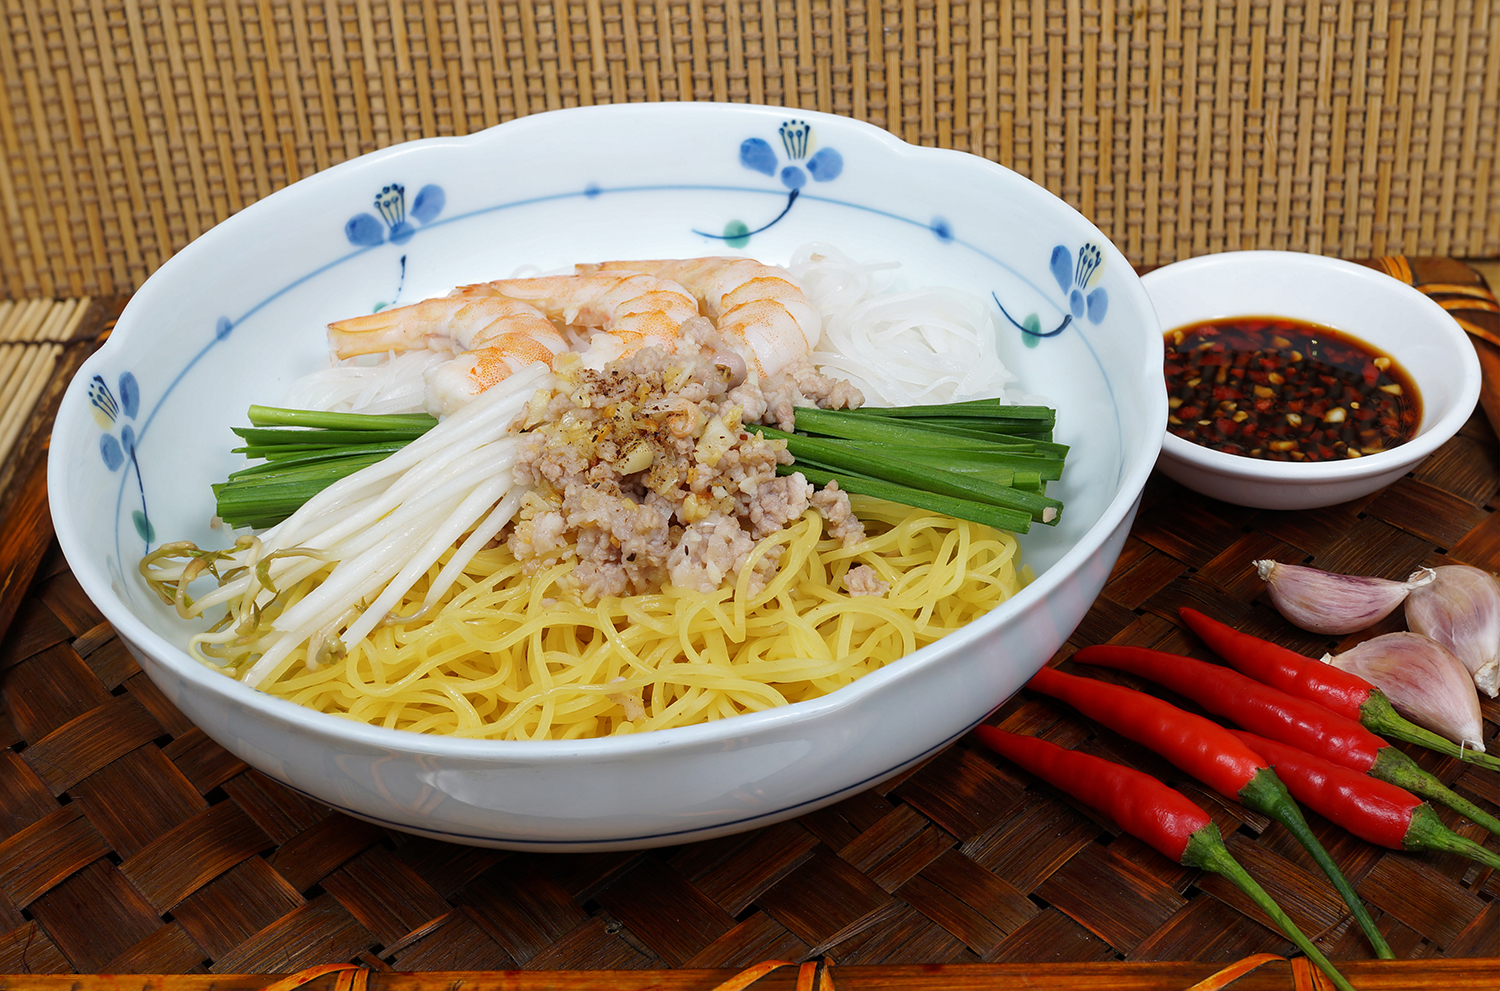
[0,0,1500,298]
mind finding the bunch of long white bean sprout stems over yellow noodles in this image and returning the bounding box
[217,364,551,685]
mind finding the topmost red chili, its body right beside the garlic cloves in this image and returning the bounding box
[1178,606,1500,771]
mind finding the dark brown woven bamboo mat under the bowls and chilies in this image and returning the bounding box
[0,259,1500,991]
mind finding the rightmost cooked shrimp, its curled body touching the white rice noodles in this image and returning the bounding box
[578,256,822,373]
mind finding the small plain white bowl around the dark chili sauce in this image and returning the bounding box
[1142,252,1479,510]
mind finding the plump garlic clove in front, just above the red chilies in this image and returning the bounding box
[1323,633,1485,753]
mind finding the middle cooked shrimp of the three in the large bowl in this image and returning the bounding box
[453,271,698,366]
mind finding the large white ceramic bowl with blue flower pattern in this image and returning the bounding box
[50,103,1166,850]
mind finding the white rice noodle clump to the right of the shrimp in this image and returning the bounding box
[788,244,1017,406]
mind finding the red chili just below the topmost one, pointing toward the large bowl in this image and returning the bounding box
[1073,645,1500,835]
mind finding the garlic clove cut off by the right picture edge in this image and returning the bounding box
[1406,564,1500,699]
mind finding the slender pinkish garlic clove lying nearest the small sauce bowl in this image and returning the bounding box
[1256,561,1433,634]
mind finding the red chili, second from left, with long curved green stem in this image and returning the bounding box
[1029,659,1395,960]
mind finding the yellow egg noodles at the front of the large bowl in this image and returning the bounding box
[263,499,1022,739]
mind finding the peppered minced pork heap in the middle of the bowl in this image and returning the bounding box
[507,318,884,601]
